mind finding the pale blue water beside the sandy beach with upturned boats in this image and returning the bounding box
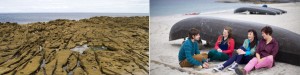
[150,0,254,16]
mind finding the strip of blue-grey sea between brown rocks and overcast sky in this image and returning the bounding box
[0,13,149,24]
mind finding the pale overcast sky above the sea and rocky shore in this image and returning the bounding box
[0,0,149,13]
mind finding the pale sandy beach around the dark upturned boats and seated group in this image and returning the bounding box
[150,2,300,75]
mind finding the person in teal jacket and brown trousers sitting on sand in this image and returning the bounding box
[178,28,209,70]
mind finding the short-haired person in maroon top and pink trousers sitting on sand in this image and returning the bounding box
[235,26,279,75]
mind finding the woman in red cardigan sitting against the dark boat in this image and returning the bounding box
[208,27,234,61]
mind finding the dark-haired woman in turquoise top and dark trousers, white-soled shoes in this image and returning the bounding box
[213,29,258,72]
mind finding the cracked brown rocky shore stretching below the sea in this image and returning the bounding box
[0,16,149,75]
